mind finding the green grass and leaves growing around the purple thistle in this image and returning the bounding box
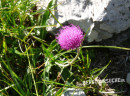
[0,0,130,96]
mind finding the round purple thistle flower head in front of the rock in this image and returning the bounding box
[56,24,84,50]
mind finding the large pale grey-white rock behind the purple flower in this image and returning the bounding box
[38,0,130,42]
